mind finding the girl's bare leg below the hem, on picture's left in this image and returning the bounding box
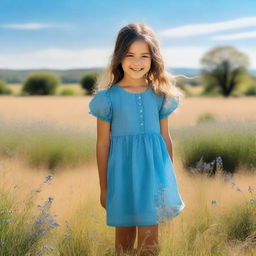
[115,226,136,256]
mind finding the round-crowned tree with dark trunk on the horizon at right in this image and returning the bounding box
[200,46,249,97]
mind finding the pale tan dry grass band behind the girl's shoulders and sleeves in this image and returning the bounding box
[0,96,256,131]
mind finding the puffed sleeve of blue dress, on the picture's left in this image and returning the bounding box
[88,90,112,122]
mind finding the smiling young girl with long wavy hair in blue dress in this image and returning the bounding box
[89,23,185,255]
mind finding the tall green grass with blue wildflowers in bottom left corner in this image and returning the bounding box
[0,176,59,256]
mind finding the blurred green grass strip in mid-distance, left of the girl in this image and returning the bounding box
[0,122,95,169]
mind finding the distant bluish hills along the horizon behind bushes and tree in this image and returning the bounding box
[0,68,256,84]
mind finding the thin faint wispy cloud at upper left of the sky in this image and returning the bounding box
[0,23,70,30]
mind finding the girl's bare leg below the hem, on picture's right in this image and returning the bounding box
[137,224,160,256]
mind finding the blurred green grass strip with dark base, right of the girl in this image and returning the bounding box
[173,121,256,173]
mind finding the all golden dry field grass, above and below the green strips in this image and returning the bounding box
[0,96,256,255]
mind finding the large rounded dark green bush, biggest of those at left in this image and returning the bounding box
[22,72,60,95]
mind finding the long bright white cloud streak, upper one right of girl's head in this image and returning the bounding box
[158,17,256,38]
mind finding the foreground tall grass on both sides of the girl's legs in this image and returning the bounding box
[0,171,256,256]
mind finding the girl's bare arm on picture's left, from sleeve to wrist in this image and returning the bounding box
[96,118,110,191]
